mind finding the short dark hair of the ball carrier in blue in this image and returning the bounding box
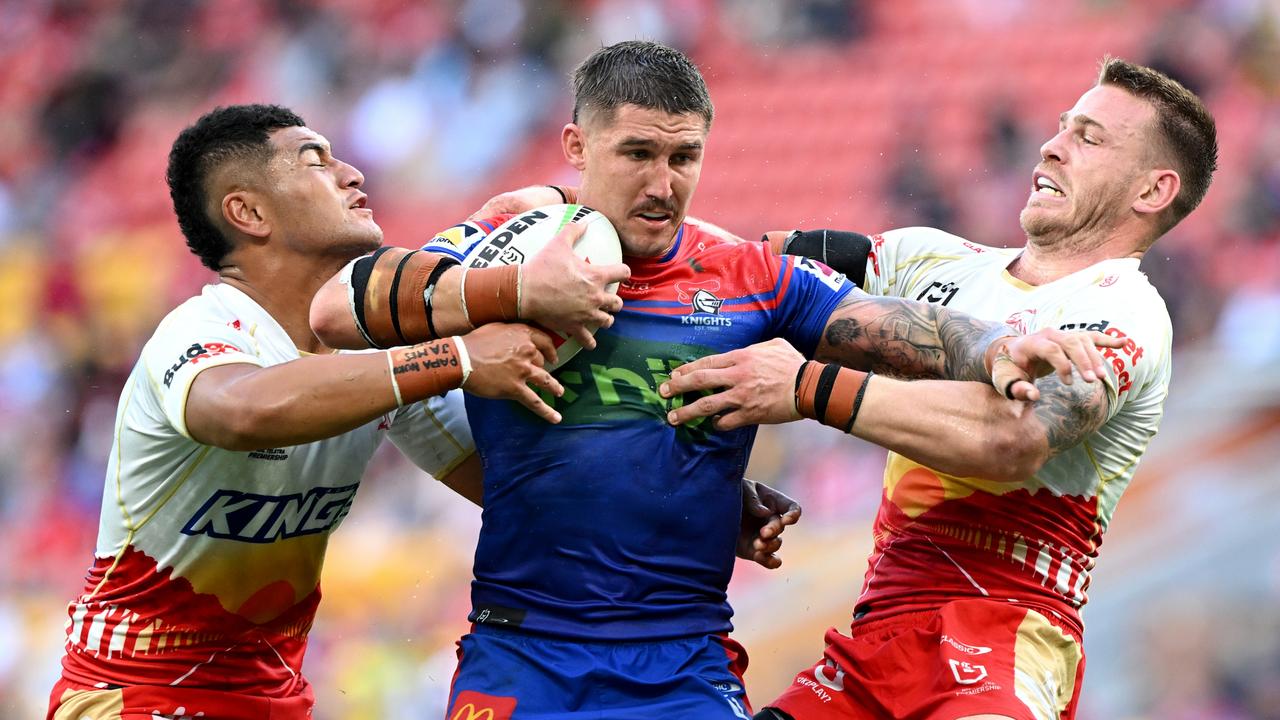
[573,40,716,128]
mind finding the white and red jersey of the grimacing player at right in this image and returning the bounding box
[859,228,1172,626]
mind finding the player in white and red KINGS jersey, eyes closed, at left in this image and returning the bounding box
[47,105,609,720]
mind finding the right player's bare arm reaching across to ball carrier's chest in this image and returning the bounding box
[659,331,1116,482]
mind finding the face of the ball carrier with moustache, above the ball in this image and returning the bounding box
[563,105,708,256]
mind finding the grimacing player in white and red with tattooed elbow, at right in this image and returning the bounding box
[662,58,1217,720]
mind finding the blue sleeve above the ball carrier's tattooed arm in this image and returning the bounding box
[760,245,855,357]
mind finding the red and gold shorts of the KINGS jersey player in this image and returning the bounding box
[45,678,315,720]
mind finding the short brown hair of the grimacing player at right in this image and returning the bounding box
[1098,56,1217,234]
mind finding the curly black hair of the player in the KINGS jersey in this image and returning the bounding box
[165,105,306,270]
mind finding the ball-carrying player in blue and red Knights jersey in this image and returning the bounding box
[304,41,1116,720]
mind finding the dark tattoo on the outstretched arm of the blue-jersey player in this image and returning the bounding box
[817,292,1014,382]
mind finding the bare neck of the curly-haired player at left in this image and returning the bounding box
[218,256,338,354]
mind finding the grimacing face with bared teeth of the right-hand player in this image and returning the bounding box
[1019,85,1156,245]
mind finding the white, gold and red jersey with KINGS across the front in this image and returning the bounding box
[63,284,474,698]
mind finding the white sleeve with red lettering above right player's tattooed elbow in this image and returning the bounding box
[1028,277,1172,419]
